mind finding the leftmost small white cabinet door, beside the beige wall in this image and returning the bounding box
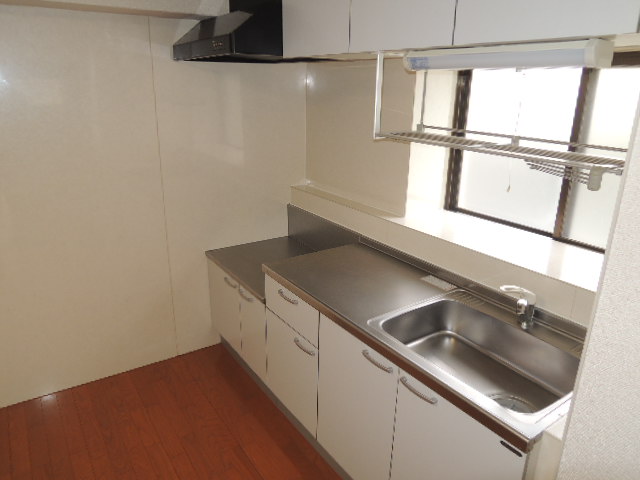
[209,262,241,352]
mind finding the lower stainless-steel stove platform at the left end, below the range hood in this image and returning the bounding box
[206,237,313,303]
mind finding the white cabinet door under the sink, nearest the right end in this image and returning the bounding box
[391,371,526,480]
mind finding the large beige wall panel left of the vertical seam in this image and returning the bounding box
[0,6,176,406]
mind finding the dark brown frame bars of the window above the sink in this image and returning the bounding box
[444,56,640,253]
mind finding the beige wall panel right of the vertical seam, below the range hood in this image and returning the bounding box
[151,19,306,353]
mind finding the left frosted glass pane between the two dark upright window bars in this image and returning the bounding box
[458,68,582,232]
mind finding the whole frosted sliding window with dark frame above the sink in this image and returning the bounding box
[445,61,640,251]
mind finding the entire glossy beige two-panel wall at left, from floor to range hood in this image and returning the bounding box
[0,6,305,406]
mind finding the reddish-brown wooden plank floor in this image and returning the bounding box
[0,345,338,480]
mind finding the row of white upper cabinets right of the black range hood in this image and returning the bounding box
[282,0,640,57]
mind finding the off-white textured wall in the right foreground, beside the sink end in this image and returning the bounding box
[558,93,640,480]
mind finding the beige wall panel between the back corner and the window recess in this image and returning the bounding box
[307,60,415,215]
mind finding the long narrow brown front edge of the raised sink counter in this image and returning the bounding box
[262,265,537,453]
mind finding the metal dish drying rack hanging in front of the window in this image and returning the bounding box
[373,52,627,191]
